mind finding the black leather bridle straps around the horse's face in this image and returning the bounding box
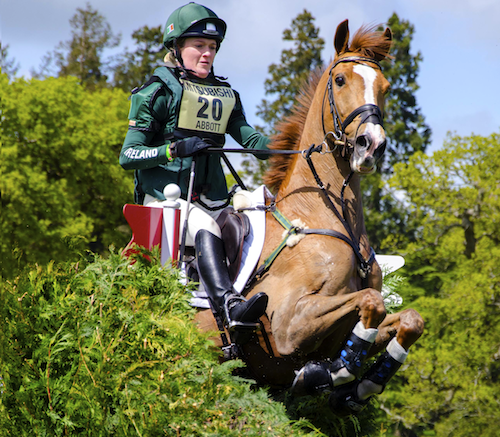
[321,56,383,157]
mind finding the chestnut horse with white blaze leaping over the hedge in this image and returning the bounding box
[198,20,423,414]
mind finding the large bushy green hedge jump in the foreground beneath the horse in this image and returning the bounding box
[0,253,340,436]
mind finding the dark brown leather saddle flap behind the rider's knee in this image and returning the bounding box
[217,208,250,283]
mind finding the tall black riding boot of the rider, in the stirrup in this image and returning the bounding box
[195,229,268,329]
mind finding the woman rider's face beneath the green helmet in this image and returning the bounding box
[180,38,217,79]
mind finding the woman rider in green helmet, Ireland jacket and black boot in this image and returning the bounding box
[120,3,269,326]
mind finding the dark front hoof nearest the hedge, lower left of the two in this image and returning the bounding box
[291,361,333,396]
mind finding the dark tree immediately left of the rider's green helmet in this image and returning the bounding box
[113,26,164,92]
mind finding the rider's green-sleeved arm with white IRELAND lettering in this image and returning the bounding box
[119,83,171,170]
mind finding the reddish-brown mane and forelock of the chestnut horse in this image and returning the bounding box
[263,26,391,192]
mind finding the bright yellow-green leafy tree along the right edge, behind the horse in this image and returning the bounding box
[376,133,500,437]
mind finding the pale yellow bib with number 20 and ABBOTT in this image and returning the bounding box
[178,80,236,134]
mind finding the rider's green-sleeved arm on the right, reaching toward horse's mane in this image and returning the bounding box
[227,92,270,159]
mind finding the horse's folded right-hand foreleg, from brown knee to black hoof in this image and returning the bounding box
[329,309,424,415]
